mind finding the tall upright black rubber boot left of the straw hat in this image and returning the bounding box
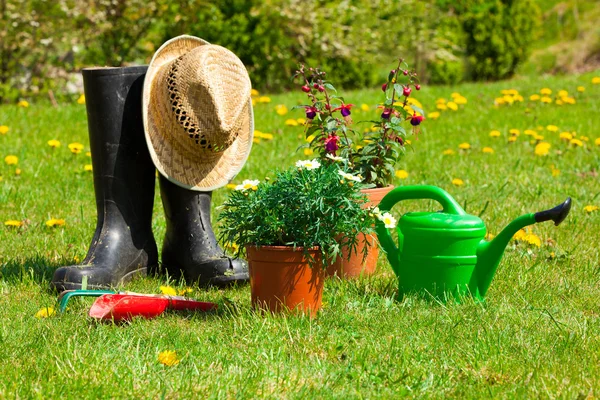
[51,66,158,291]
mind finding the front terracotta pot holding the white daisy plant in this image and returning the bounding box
[246,246,325,317]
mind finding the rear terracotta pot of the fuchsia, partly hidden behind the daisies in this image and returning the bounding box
[327,185,394,278]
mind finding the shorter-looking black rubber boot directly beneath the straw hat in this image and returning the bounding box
[159,176,250,286]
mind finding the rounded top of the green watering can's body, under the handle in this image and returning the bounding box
[400,212,486,237]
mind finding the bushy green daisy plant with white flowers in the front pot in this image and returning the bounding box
[219,160,390,263]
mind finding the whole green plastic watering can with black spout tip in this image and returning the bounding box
[376,186,571,300]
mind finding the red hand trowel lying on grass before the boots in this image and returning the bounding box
[89,293,217,321]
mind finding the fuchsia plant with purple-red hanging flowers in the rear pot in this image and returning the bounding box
[294,59,425,187]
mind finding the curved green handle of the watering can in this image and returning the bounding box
[376,185,467,270]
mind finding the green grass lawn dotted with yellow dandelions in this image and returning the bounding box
[0,72,600,399]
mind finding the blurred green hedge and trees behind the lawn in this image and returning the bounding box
[0,0,600,102]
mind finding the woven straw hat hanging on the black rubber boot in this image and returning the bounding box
[142,35,254,191]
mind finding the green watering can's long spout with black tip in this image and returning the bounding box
[476,197,571,297]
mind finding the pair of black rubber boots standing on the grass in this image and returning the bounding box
[51,66,248,291]
